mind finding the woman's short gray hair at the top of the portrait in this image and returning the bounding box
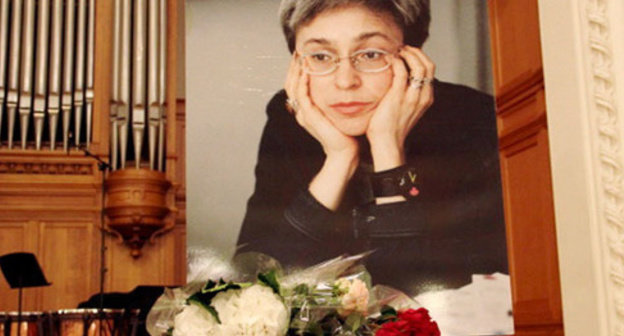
[279,0,431,53]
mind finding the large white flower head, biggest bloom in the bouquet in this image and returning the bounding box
[212,285,289,336]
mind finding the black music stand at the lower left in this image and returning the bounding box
[0,252,51,335]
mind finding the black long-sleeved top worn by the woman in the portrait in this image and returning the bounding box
[238,81,507,295]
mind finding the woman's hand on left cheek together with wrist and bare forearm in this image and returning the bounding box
[285,53,359,210]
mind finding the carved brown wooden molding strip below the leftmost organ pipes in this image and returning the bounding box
[0,160,93,175]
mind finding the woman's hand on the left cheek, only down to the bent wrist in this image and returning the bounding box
[284,52,358,159]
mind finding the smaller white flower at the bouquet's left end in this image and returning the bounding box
[173,304,217,336]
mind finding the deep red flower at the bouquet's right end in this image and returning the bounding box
[375,308,440,336]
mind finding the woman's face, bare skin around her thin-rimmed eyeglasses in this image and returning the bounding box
[296,6,403,136]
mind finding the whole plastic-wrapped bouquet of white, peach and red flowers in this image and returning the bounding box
[147,254,440,336]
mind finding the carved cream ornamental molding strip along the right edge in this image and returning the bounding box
[585,0,624,335]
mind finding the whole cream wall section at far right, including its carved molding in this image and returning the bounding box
[539,0,624,336]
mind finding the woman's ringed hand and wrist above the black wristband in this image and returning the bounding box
[366,46,435,171]
